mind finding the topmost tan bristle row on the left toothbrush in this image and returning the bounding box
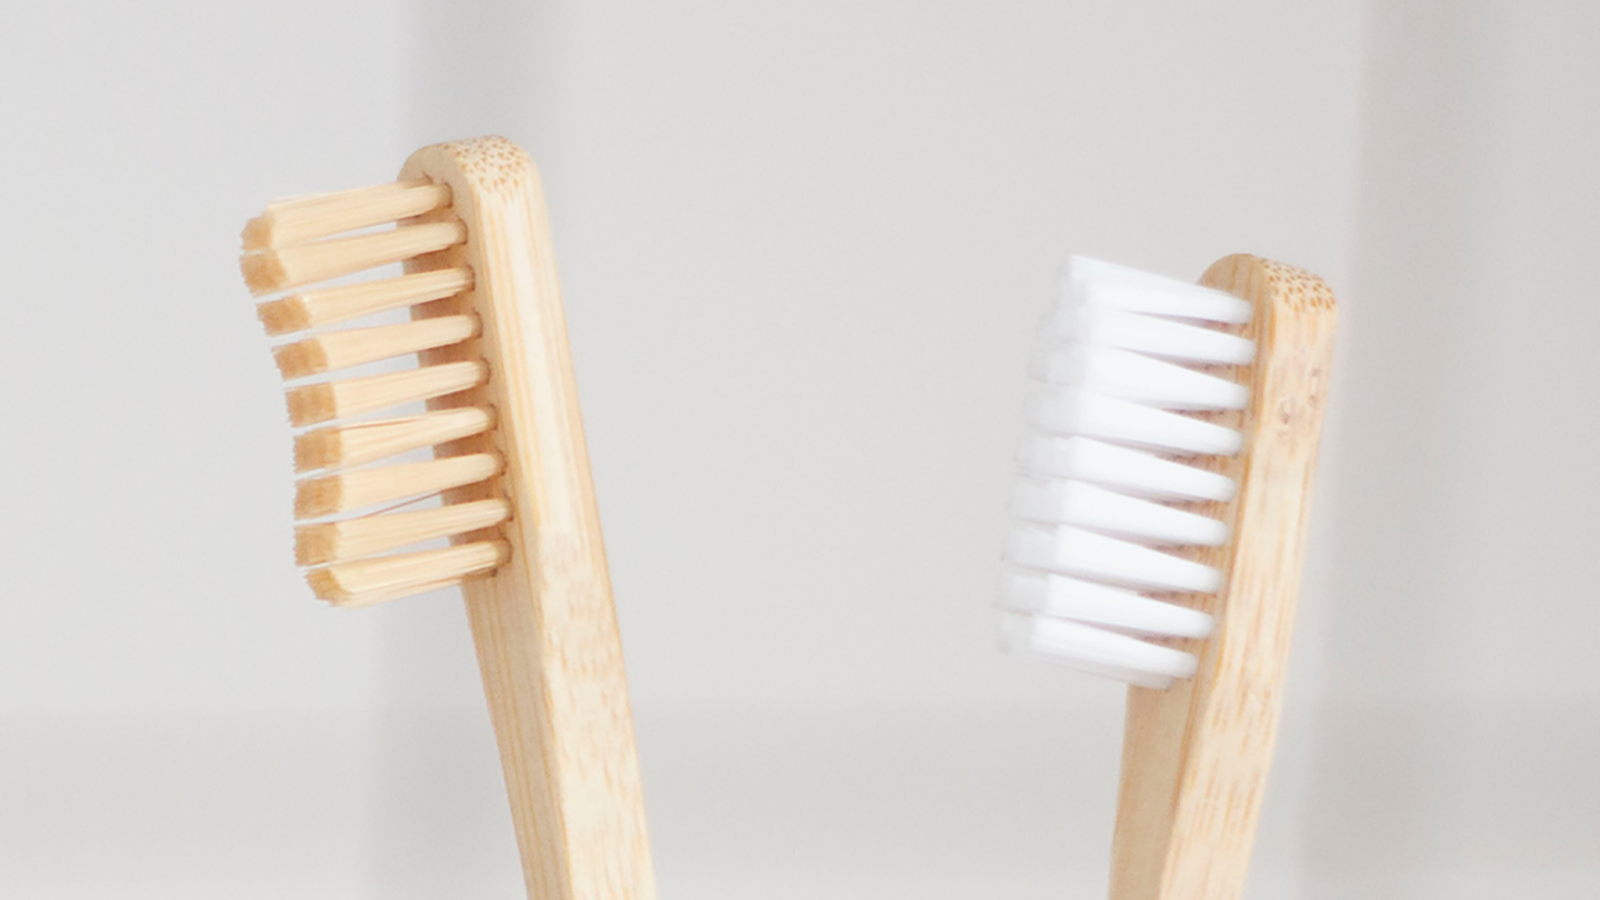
[242,181,450,250]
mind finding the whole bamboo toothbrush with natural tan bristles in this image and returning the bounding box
[240,138,656,900]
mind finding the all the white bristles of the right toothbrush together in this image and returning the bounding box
[1000,256,1256,689]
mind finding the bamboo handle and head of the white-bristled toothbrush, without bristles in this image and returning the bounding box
[1110,255,1334,900]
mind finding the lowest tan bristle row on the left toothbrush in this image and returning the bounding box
[306,541,510,607]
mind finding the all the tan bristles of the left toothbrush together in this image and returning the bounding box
[240,181,510,607]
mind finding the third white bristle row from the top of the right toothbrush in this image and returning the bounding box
[1030,341,1250,410]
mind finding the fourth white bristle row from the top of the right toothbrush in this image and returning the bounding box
[1027,386,1243,456]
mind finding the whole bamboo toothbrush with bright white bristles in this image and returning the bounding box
[1000,255,1334,900]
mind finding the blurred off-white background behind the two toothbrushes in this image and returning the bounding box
[0,0,1600,900]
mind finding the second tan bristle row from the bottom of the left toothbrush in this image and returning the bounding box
[294,500,510,565]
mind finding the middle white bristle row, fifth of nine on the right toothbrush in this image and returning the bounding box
[1016,434,1234,503]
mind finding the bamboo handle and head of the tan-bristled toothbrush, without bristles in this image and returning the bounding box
[400,138,656,900]
